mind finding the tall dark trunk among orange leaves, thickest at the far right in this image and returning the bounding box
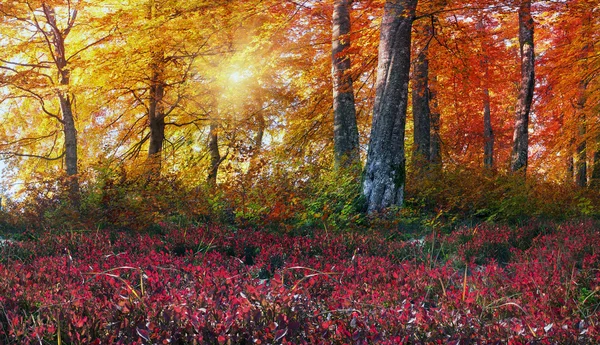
[511,0,535,173]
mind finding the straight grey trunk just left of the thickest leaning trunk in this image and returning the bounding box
[331,0,360,167]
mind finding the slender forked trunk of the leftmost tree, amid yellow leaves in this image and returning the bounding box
[42,4,79,209]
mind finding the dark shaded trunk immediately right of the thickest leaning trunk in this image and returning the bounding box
[412,42,431,164]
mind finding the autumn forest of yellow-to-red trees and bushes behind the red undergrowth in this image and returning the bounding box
[0,0,600,230]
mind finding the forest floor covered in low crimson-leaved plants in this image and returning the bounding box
[0,222,600,344]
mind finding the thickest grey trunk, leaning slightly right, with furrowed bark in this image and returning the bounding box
[363,0,417,212]
